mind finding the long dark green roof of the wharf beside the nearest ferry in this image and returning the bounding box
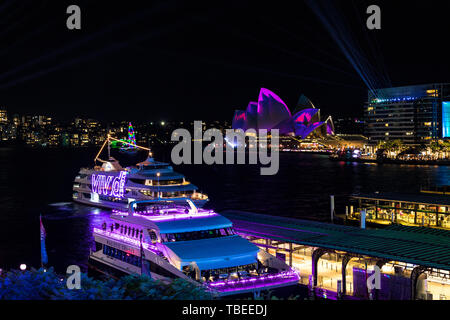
[220,210,450,270]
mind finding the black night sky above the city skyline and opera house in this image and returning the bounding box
[0,0,450,121]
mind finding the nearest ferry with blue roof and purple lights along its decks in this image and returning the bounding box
[88,198,299,297]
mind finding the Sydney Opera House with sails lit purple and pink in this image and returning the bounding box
[232,88,335,139]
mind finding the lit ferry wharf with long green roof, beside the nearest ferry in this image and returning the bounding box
[220,210,450,300]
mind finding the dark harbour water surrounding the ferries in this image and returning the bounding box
[0,148,450,271]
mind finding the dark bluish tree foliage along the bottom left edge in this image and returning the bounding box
[0,268,215,300]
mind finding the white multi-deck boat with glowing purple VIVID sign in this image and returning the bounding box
[72,136,208,209]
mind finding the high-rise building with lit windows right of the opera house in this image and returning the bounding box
[364,84,450,145]
